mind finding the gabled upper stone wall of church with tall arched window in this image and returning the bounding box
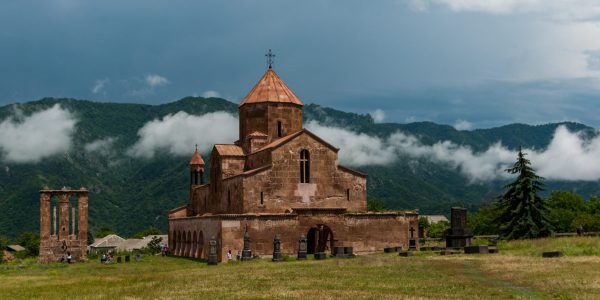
[243,133,367,213]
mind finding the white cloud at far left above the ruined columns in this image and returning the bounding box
[0,104,77,163]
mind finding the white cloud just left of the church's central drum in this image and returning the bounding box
[128,111,238,158]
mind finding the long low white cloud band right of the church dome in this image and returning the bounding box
[306,121,600,182]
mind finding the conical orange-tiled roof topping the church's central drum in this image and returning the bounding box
[240,68,304,106]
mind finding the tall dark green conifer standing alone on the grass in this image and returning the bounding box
[497,148,552,239]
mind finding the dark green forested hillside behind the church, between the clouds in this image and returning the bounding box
[0,97,600,237]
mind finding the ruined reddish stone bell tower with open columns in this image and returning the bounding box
[38,187,88,263]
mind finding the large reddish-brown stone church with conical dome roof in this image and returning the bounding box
[169,66,418,261]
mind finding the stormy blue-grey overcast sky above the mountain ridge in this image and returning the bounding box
[0,0,600,129]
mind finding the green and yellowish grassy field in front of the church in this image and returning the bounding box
[0,238,600,299]
